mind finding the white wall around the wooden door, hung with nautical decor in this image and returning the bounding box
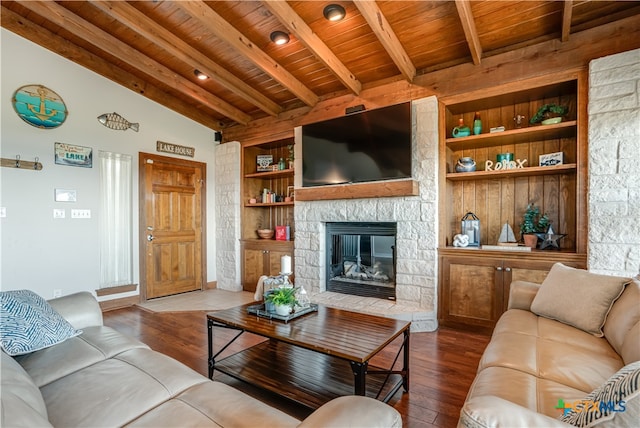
[0,29,217,298]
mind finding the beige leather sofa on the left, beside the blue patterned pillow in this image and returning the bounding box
[0,293,402,428]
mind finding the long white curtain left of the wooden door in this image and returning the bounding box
[99,151,133,288]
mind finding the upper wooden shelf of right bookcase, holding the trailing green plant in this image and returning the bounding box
[445,120,577,150]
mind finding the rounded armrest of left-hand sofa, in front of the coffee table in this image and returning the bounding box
[298,395,402,428]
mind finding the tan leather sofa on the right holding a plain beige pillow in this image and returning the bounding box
[458,271,640,427]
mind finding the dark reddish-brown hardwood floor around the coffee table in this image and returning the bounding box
[104,307,489,427]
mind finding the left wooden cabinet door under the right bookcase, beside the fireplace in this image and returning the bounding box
[440,257,503,327]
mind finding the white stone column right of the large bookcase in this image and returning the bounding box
[588,49,640,276]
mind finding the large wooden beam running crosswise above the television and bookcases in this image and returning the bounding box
[225,15,640,143]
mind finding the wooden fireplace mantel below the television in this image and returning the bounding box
[295,180,420,201]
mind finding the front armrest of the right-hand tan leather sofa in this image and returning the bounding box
[458,395,572,428]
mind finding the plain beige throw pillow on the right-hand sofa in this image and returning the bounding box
[531,263,630,337]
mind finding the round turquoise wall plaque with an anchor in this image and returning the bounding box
[12,85,69,129]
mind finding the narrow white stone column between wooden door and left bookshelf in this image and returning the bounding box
[215,141,242,291]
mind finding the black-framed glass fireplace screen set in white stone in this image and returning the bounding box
[326,223,396,300]
